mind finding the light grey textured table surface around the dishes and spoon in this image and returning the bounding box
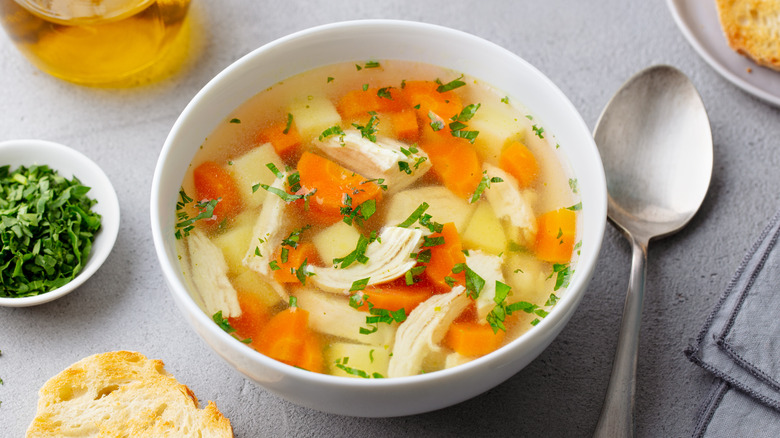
[0,0,780,437]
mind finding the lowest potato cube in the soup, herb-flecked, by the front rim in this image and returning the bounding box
[325,342,390,377]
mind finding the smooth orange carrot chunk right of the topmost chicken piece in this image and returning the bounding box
[420,137,482,199]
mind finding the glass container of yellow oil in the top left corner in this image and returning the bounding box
[0,0,190,86]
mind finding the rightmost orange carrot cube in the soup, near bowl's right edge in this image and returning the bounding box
[536,208,577,263]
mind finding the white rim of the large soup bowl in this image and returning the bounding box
[150,19,607,388]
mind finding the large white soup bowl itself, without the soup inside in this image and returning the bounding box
[150,20,607,417]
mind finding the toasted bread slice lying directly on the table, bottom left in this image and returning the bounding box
[26,351,233,438]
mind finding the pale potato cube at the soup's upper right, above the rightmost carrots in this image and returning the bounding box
[468,101,525,163]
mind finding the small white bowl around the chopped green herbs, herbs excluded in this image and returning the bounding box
[0,140,119,307]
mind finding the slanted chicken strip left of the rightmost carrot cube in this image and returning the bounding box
[483,163,536,246]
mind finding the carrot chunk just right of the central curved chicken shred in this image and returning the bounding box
[423,222,466,291]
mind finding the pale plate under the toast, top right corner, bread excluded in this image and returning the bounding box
[667,0,780,106]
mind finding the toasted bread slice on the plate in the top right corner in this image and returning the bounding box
[716,0,780,70]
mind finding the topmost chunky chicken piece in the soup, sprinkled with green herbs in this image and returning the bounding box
[313,129,431,194]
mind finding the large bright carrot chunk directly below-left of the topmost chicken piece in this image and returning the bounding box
[298,152,382,225]
